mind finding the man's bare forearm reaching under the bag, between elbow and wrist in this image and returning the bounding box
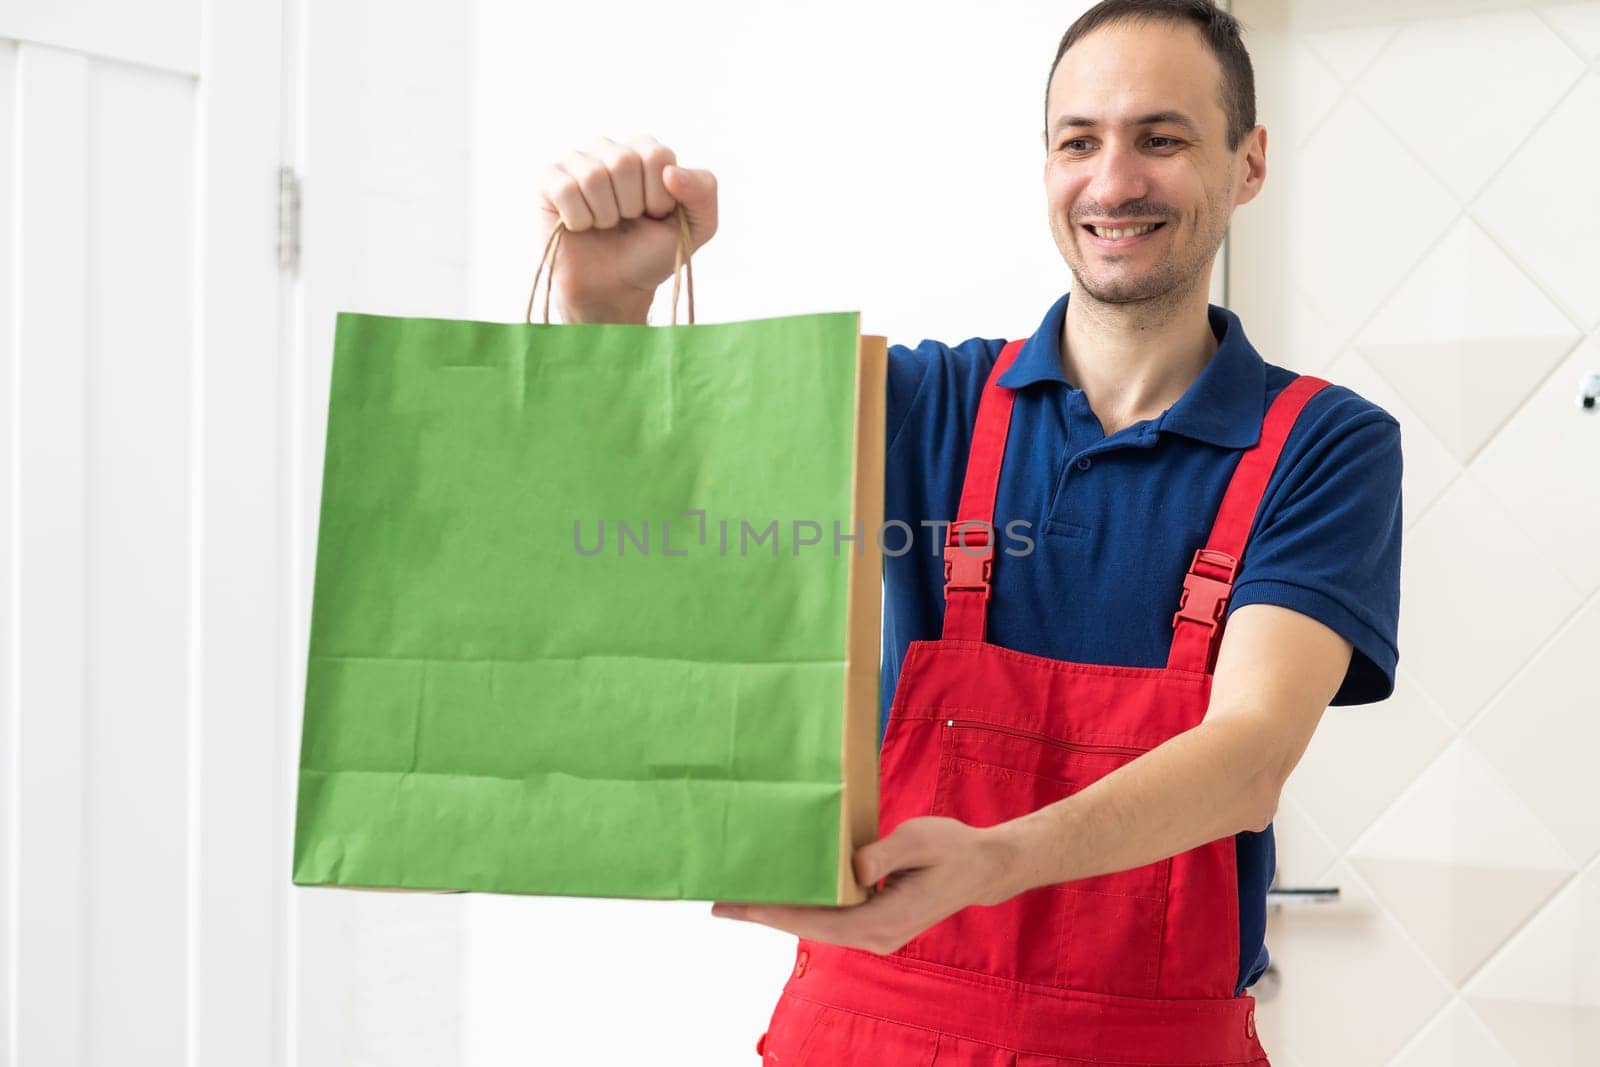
[995,717,1282,899]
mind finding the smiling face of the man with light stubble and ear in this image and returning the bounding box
[1045,21,1266,304]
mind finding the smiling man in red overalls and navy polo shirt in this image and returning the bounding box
[542,0,1402,1067]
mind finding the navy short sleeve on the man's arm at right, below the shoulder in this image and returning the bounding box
[1229,396,1402,704]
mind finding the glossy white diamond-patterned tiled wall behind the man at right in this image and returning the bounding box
[1229,0,1600,1067]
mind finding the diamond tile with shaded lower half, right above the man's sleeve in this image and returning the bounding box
[1357,219,1582,462]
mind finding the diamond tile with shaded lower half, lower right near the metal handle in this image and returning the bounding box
[1350,741,1574,984]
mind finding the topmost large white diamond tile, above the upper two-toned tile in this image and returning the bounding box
[1357,11,1586,202]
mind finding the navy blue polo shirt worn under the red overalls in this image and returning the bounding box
[880,293,1400,992]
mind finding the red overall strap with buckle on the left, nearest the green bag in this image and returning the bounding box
[944,341,1022,641]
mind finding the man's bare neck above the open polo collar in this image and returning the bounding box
[1061,288,1218,437]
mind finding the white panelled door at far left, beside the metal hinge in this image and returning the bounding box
[0,0,290,1067]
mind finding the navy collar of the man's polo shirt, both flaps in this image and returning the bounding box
[997,293,1267,448]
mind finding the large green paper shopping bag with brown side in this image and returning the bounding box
[293,314,885,904]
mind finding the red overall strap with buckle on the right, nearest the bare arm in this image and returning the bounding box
[1166,374,1328,673]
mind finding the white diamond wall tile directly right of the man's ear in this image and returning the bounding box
[1269,98,1458,337]
